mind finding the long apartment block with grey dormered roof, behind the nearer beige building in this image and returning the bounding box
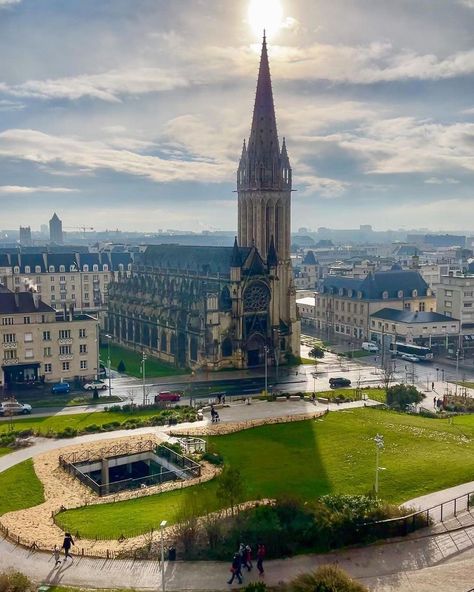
[0,252,132,312]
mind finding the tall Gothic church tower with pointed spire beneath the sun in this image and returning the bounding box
[237,34,300,356]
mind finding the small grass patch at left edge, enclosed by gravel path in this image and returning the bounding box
[0,459,44,516]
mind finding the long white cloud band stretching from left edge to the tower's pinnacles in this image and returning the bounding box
[0,129,235,183]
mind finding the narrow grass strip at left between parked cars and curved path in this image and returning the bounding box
[0,409,191,435]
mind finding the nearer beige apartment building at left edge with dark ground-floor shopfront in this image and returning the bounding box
[0,287,98,388]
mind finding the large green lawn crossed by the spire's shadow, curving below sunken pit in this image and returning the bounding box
[57,408,474,538]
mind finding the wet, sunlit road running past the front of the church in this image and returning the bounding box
[0,345,474,421]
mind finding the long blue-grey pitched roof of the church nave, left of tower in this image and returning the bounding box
[137,245,252,275]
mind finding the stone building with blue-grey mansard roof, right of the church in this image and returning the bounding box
[313,266,436,340]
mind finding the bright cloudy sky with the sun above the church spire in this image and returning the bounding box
[0,0,474,231]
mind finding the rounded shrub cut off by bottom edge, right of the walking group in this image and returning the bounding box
[289,565,368,592]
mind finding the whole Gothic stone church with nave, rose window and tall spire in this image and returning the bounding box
[106,37,300,370]
